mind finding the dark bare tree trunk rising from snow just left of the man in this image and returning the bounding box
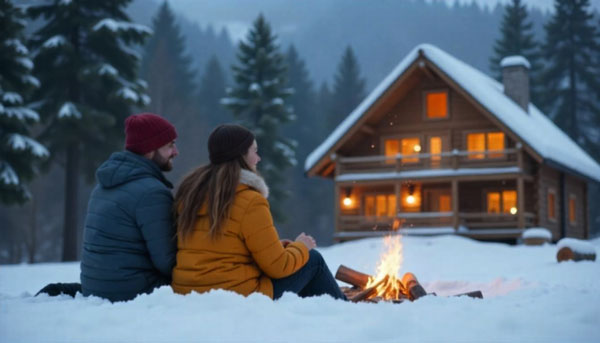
[62,143,79,261]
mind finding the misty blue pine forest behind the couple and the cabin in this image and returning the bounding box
[0,0,600,263]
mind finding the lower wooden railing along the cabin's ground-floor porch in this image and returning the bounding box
[338,212,535,231]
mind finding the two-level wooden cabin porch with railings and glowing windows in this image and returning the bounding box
[334,146,536,240]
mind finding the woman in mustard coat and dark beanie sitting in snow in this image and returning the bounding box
[172,125,345,299]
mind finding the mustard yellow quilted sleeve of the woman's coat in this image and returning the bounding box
[241,196,309,279]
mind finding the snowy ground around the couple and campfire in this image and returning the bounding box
[0,236,600,342]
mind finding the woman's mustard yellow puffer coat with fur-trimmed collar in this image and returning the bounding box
[172,170,309,298]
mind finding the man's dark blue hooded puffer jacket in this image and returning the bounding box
[81,151,177,301]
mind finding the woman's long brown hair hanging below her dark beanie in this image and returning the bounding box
[173,156,250,239]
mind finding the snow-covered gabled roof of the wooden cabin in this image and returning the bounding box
[304,44,600,182]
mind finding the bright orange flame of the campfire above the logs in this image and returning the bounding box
[366,235,403,300]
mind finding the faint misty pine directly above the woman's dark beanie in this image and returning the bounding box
[198,55,232,127]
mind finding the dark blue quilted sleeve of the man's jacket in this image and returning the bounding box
[136,188,177,280]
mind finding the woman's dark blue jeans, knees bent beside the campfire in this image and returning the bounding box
[272,249,347,300]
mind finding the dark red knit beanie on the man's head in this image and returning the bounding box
[125,113,177,155]
